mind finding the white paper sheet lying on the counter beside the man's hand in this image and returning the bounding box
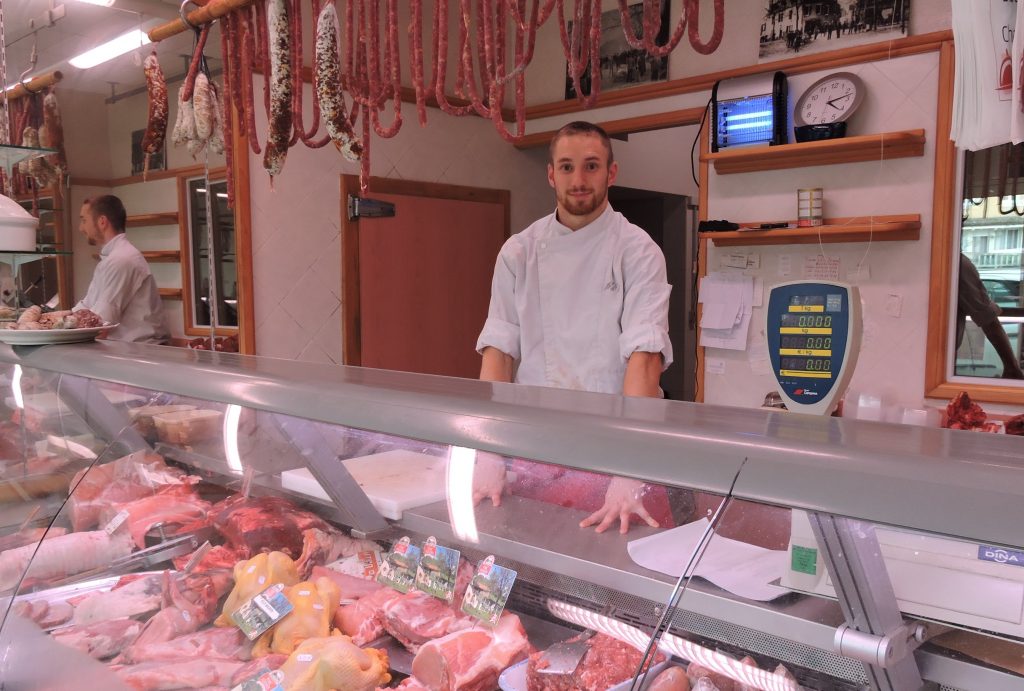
[627,518,791,602]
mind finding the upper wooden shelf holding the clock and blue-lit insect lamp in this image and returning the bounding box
[700,130,925,175]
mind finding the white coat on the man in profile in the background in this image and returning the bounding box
[75,233,168,343]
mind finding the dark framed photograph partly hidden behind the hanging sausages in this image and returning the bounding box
[565,0,678,98]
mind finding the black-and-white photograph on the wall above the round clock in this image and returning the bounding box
[758,0,910,62]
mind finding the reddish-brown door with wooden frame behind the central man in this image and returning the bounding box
[341,175,510,379]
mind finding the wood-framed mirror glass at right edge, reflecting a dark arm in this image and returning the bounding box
[952,144,1024,380]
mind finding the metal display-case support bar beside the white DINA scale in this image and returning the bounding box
[808,513,934,691]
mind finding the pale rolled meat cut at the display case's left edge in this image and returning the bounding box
[0,530,132,591]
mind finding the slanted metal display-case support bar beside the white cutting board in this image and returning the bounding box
[273,415,391,539]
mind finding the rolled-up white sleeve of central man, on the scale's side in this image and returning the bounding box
[618,243,673,372]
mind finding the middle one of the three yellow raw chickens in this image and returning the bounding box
[253,578,341,656]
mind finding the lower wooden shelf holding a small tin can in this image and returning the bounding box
[699,214,921,247]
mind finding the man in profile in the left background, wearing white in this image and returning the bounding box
[75,195,169,344]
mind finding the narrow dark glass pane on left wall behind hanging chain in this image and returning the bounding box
[182,177,239,333]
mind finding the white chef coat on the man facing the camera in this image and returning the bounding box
[476,206,672,393]
